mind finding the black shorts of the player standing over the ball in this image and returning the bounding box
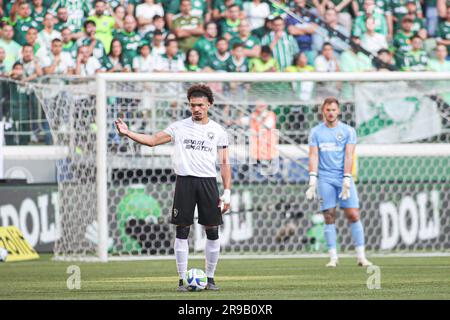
[170,176,223,226]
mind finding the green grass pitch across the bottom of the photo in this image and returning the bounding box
[0,255,450,300]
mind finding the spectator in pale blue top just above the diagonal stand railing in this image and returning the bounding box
[313,9,350,56]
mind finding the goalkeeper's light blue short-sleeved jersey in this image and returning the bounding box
[309,122,356,180]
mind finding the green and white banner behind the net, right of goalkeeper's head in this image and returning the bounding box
[354,81,442,143]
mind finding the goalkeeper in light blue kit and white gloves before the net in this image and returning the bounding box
[306,98,372,267]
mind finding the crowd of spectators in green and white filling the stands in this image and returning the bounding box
[0,0,450,81]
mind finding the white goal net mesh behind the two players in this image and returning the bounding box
[34,77,450,259]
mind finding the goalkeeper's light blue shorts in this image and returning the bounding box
[317,178,359,211]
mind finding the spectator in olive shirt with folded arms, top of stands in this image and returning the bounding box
[172,0,204,52]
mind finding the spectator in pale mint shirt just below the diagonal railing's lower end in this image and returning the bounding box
[339,36,374,72]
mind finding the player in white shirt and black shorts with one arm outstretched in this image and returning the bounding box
[116,85,231,291]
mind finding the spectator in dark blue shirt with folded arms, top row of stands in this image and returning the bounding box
[286,0,317,64]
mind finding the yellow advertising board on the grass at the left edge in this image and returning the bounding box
[0,226,39,262]
